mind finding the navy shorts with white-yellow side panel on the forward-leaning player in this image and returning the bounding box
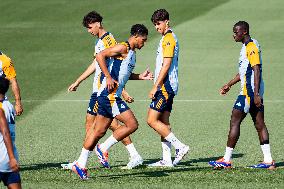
[98,96,129,118]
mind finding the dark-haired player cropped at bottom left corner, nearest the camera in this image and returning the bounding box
[0,77,21,189]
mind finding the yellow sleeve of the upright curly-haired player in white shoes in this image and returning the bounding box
[162,33,176,58]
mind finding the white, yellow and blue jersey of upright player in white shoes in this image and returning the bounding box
[154,30,179,96]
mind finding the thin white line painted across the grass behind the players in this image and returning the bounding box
[19,99,284,103]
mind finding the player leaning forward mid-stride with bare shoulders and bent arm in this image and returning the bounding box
[72,24,148,179]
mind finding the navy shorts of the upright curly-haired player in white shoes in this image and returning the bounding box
[150,90,175,112]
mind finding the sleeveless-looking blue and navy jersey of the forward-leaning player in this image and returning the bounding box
[98,41,136,99]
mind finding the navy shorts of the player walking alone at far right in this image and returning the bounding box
[234,95,264,113]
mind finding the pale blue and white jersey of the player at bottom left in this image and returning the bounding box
[0,99,18,172]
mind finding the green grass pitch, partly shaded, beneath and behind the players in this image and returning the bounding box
[0,0,284,189]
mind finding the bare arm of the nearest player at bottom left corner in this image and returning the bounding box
[0,109,19,171]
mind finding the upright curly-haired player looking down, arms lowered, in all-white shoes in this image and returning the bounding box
[147,9,189,167]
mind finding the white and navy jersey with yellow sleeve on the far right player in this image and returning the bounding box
[239,39,264,97]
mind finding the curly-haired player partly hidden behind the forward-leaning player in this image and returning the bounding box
[62,11,152,169]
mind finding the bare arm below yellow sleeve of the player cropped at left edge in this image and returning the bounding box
[9,77,24,116]
